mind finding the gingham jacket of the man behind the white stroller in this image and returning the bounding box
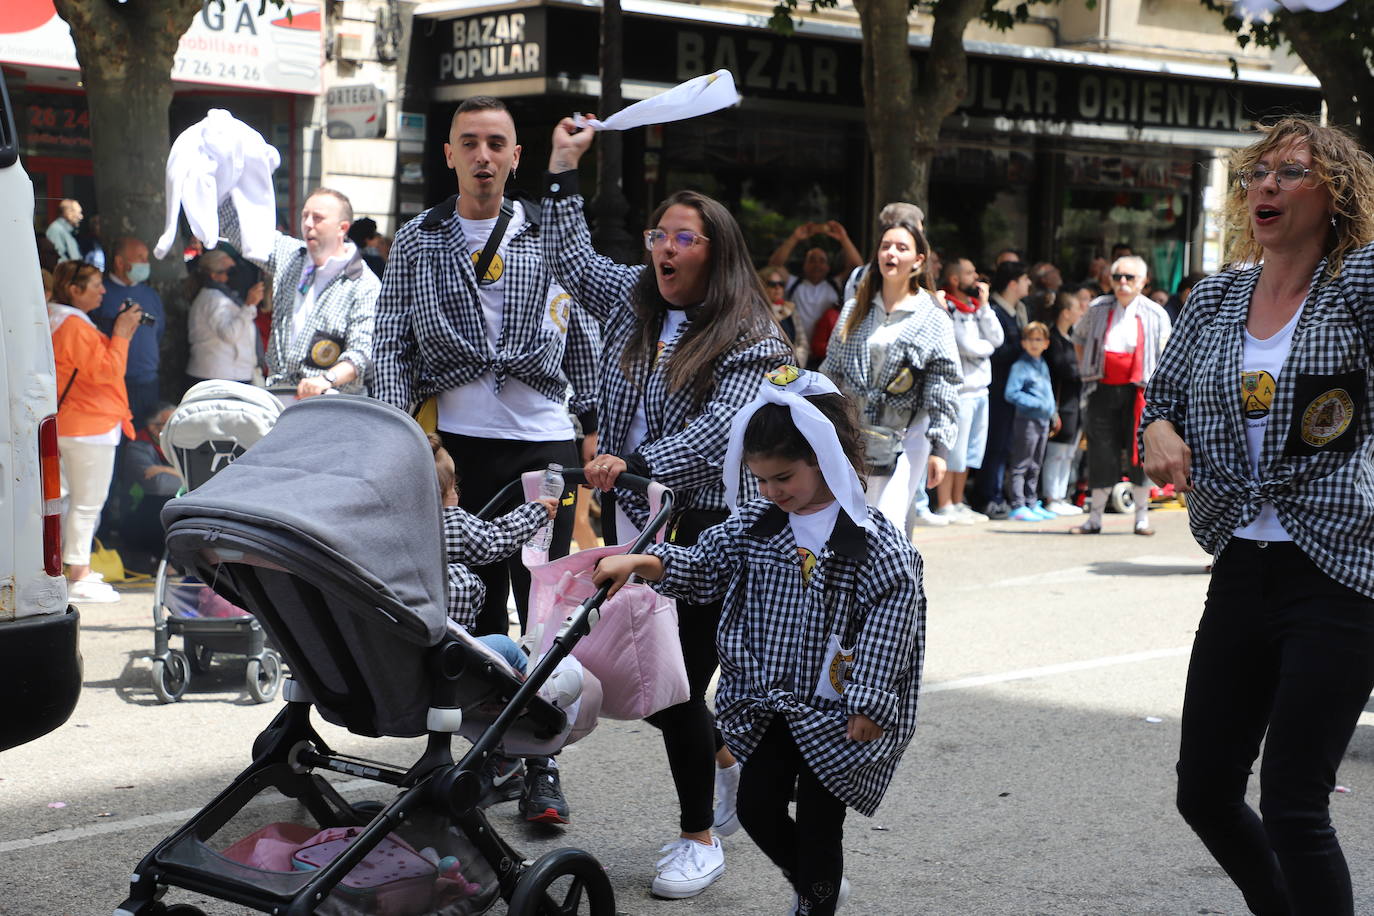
[220,199,382,394]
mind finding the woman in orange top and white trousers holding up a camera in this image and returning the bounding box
[48,261,143,603]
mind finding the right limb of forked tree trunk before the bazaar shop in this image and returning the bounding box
[907,0,982,211]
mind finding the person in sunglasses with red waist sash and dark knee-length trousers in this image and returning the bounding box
[1069,254,1172,536]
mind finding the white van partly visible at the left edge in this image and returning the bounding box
[0,74,81,751]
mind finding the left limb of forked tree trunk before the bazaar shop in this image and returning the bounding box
[855,0,923,216]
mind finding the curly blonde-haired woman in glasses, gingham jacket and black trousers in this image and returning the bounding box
[1142,118,1374,916]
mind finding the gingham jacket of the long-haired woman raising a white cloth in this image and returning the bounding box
[543,172,796,527]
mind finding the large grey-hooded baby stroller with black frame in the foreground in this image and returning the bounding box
[115,396,671,916]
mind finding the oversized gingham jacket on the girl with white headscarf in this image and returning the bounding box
[649,500,926,817]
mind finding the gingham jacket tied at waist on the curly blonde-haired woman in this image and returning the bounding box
[1140,243,1374,597]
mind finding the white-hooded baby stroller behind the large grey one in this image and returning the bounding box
[153,380,282,703]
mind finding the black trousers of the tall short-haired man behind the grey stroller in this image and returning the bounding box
[438,433,583,636]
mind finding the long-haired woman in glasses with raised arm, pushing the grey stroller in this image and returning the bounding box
[540,118,794,898]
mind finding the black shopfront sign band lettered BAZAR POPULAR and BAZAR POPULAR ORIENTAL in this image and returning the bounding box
[412,7,1320,130]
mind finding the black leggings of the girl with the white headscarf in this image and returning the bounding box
[736,715,848,916]
